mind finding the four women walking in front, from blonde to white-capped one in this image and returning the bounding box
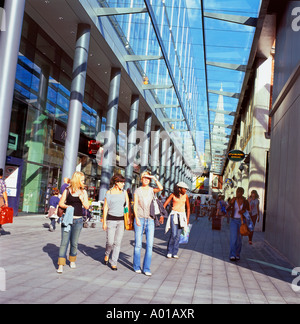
[57,171,190,276]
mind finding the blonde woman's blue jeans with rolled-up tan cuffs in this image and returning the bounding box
[58,218,83,265]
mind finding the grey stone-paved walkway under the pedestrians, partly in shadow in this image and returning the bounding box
[0,215,300,305]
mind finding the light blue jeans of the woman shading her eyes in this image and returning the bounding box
[133,218,155,272]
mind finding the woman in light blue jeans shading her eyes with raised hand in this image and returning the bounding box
[133,171,163,276]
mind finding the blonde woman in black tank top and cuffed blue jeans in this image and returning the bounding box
[57,171,89,273]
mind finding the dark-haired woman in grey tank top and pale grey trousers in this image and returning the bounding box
[103,174,130,271]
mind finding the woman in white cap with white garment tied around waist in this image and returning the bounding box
[164,182,190,259]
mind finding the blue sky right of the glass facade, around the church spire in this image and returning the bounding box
[186,0,261,171]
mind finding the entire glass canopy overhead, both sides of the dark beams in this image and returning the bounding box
[89,0,261,174]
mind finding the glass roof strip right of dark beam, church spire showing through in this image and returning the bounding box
[202,0,261,174]
